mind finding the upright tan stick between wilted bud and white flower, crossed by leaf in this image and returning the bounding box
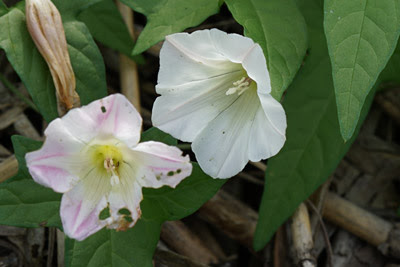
[117,1,140,112]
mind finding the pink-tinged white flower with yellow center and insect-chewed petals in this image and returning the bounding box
[26,94,192,240]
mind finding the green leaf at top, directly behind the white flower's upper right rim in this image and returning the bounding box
[225,0,307,101]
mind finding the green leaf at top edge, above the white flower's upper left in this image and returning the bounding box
[122,0,220,55]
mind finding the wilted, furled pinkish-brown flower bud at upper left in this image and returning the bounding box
[25,0,80,115]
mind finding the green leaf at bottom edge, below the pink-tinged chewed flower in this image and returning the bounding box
[65,219,161,267]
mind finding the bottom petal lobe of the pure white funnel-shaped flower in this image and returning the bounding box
[192,88,261,178]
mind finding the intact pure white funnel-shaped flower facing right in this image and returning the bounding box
[152,29,286,178]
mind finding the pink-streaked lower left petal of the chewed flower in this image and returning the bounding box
[60,169,110,243]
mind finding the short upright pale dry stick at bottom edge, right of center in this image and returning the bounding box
[291,203,316,267]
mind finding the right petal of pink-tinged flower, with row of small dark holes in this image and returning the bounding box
[132,141,192,188]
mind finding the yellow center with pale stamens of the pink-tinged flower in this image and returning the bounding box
[92,145,122,186]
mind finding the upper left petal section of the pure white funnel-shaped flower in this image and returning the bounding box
[156,30,242,89]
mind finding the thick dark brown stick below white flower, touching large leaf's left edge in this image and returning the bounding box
[198,191,258,249]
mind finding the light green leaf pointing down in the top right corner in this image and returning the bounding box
[324,0,400,141]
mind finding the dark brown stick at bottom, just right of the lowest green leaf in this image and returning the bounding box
[161,221,218,264]
